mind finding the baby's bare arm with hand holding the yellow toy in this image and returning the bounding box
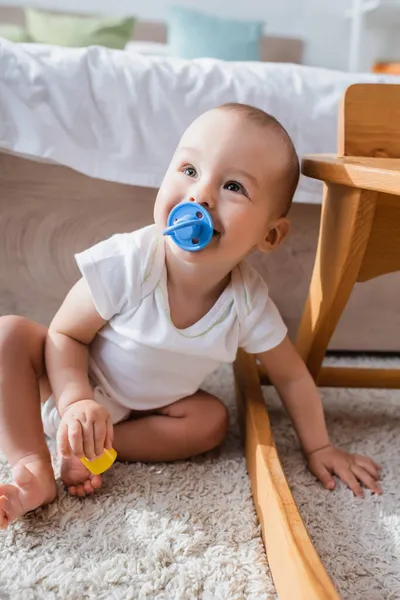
[45,279,112,459]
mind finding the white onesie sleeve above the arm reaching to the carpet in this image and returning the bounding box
[239,265,287,354]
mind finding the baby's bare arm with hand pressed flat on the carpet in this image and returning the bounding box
[258,337,381,496]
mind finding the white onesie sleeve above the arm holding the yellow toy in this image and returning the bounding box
[75,233,141,321]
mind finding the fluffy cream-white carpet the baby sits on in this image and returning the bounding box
[0,361,400,600]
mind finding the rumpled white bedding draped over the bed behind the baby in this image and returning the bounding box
[0,39,399,202]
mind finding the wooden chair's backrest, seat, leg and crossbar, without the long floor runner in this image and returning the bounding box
[297,84,400,388]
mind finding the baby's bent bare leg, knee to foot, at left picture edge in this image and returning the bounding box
[0,317,57,529]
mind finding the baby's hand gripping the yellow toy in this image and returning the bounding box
[57,399,113,460]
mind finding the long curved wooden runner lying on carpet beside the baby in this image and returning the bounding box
[234,351,340,600]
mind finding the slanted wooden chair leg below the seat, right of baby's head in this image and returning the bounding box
[296,184,377,380]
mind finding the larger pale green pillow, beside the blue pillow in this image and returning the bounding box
[25,8,135,50]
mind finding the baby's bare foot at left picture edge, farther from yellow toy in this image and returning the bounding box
[0,457,57,529]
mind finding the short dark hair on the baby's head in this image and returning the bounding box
[218,102,300,216]
